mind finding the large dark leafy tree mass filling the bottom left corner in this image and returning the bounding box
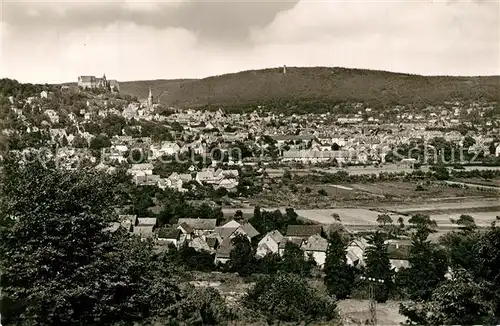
[0,158,196,325]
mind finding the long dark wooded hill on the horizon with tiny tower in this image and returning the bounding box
[99,67,500,108]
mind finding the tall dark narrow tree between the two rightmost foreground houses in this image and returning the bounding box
[365,231,393,302]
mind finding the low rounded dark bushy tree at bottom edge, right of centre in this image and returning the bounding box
[244,272,338,323]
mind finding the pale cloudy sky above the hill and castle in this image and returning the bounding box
[0,0,500,82]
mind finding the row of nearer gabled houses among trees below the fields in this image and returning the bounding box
[109,215,409,271]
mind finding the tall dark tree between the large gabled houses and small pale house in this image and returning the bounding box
[324,230,355,299]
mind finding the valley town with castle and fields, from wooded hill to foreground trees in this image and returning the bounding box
[0,75,500,324]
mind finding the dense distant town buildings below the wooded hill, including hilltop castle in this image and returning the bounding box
[4,85,500,174]
